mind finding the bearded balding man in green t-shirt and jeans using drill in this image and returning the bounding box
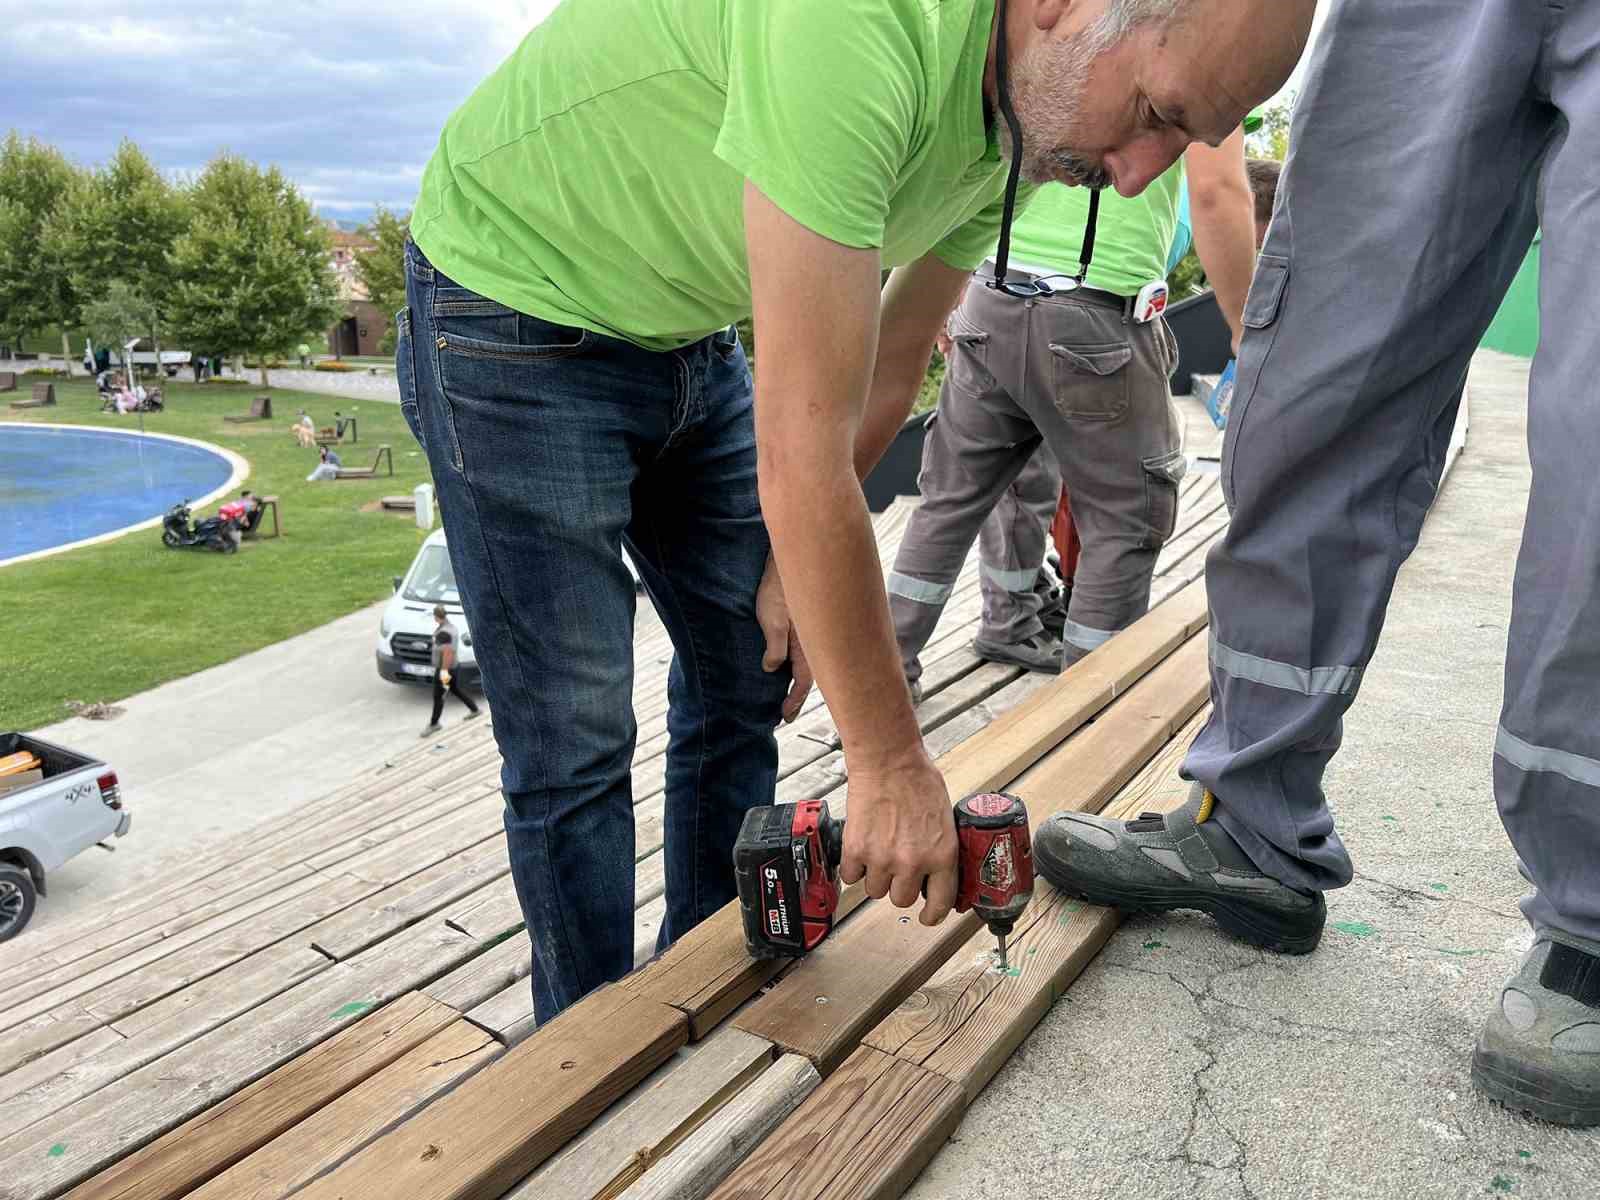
[397,0,1314,1021]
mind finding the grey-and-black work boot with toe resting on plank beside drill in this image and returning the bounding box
[1034,784,1328,954]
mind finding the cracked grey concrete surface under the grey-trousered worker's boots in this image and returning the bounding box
[907,354,1600,1200]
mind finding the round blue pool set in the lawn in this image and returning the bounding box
[0,422,234,562]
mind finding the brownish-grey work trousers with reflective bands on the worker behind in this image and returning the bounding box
[888,280,1184,680]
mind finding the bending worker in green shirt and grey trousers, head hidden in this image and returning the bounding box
[890,130,1254,684]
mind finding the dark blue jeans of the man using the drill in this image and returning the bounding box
[395,245,789,1022]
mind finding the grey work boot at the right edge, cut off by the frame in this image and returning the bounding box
[1472,930,1600,1125]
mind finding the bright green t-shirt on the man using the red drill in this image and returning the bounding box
[411,0,1005,350]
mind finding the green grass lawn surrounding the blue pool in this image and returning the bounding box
[0,379,429,730]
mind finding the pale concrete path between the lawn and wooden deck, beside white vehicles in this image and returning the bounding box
[30,605,464,930]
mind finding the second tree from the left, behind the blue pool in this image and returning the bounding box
[43,139,189,371]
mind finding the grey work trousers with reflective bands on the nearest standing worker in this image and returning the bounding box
[1184,0,1600,942]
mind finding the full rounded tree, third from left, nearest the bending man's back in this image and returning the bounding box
[170,155,341,387]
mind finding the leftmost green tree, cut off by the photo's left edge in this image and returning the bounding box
[0,133,83,371]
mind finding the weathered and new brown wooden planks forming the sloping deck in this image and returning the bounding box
[0,478,1226,1200]
